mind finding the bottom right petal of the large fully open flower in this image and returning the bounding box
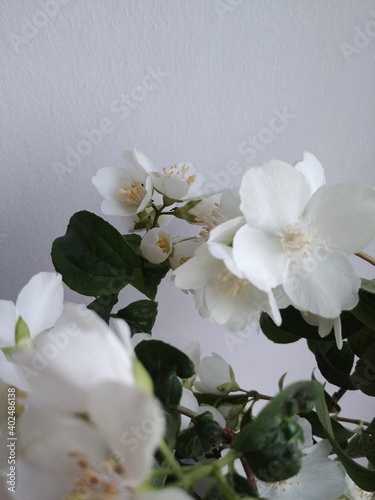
[284,254,361,319]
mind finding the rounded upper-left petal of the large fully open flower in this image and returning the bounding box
[240,160,311,233]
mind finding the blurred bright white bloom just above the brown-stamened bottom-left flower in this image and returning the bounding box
[12,304,135,415]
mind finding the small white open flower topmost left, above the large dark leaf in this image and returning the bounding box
[92,149,153,220]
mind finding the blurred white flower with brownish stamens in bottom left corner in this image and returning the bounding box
[9,381,176,500]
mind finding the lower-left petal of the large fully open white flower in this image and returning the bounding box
[233,225,289,291]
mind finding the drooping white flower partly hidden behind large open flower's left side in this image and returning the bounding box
[174,217,281,330]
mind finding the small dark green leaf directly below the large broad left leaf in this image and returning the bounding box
[113,300,158,335]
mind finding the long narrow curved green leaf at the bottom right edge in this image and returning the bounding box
[316,388,375,491]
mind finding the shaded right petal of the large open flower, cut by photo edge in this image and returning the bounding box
[306,184,375,254]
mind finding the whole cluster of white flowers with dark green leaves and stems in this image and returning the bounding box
[0,150,375,500]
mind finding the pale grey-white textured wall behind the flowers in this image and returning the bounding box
[0,0,375,418]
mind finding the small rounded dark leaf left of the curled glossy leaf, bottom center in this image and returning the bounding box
[176,411,221,458]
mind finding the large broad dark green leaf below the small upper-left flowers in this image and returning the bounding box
[52,211,141,297]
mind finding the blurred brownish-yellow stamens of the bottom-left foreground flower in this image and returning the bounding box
[64,451,129,500]
